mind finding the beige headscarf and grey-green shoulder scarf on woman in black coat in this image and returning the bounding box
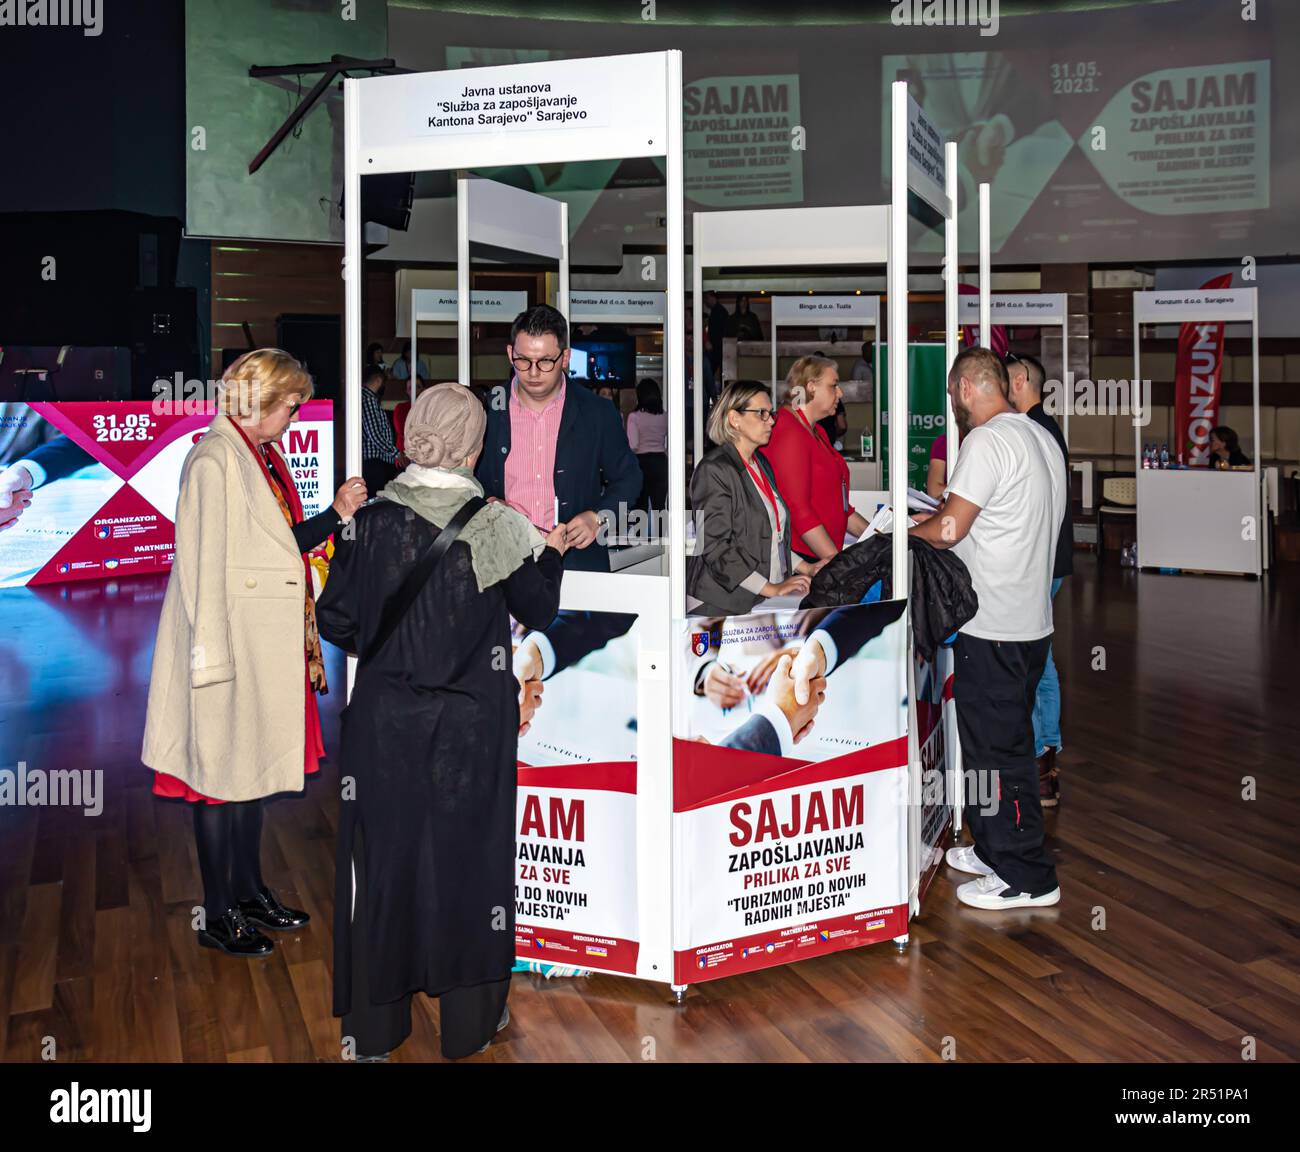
[380,384,543,592]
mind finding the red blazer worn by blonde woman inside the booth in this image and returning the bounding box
[761,406,854,556]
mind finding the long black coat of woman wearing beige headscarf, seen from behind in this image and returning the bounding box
[316,501,562,1015]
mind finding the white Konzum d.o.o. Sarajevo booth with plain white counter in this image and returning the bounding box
[1132,287,1266,576]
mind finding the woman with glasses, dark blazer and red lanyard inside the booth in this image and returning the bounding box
[686,381,820,616]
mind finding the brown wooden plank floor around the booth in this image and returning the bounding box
[0,554,1300,1061]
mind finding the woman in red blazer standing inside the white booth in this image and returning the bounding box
[763,356,867,562]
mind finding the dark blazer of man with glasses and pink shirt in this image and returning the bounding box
[475,380,641,572]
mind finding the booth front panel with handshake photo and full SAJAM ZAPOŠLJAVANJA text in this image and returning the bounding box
[673,602,907,984]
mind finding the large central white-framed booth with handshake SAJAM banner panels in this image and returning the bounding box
[345,52,972,1000]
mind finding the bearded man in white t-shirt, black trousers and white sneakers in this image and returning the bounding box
[911,348,1066,909]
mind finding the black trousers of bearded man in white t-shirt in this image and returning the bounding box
[953,632,1057,896]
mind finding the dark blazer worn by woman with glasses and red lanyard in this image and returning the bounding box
[686,443,790,616]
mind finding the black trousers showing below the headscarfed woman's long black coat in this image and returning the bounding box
[334,828,510,1060]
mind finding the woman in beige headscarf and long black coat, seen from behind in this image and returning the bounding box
[317,384,564,1060]
